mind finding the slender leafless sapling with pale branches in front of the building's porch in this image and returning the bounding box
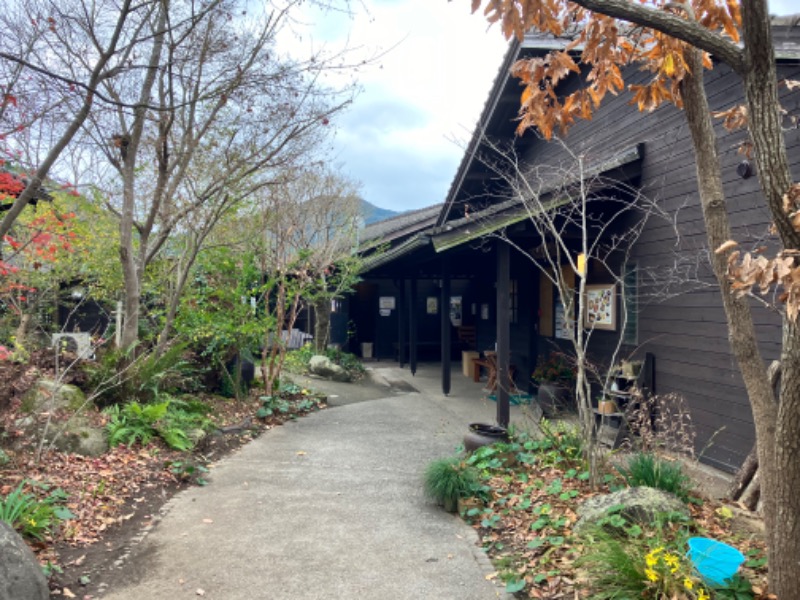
[476,137,672,482]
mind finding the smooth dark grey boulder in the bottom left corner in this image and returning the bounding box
[0,521,50,600]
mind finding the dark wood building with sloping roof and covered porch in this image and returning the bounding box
[350,20,800,471]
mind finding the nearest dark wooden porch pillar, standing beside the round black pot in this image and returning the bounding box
[495,240,511,427]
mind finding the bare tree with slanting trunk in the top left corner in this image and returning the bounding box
[0,0,161,238]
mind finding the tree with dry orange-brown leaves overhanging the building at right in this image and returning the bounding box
[472,0,800,598]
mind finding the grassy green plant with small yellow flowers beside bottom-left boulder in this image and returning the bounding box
[0,481,75,540]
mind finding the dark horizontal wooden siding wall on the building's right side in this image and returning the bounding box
[512,54,800,471]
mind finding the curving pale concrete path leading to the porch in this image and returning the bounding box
[103,363,532,600]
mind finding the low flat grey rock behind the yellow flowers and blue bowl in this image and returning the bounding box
[575,487,689,531]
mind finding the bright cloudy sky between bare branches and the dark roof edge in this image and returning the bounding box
[284,0,800,211]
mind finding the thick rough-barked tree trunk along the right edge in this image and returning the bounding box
[741,0,800,598]
